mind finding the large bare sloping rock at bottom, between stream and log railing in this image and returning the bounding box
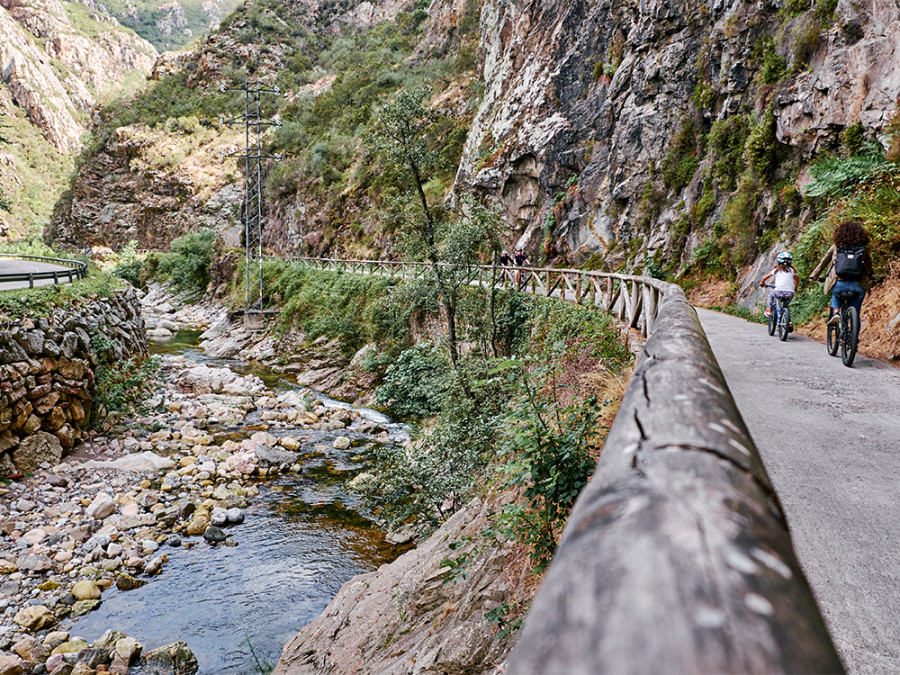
[272,499,528,675]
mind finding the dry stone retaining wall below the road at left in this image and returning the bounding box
[0,289,147,476]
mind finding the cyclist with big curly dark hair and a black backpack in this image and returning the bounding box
[809,220,872,324]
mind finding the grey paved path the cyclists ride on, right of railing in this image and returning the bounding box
[698,310,900,673]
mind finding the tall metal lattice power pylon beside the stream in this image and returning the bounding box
[223,82,281,318]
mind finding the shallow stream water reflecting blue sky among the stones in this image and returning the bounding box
[70,332,405,675]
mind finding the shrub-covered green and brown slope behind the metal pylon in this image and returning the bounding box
[49,0,474,254]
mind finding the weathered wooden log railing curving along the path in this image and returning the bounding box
[274,258,843,675]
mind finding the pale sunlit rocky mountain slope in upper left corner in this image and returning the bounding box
[0,0,157,230]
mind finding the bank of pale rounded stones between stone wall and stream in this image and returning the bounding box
[0,288,400,675]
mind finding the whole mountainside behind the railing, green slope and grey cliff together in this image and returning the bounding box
[51,0,900,362]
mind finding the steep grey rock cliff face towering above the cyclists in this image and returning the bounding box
[456,0,900,266]
